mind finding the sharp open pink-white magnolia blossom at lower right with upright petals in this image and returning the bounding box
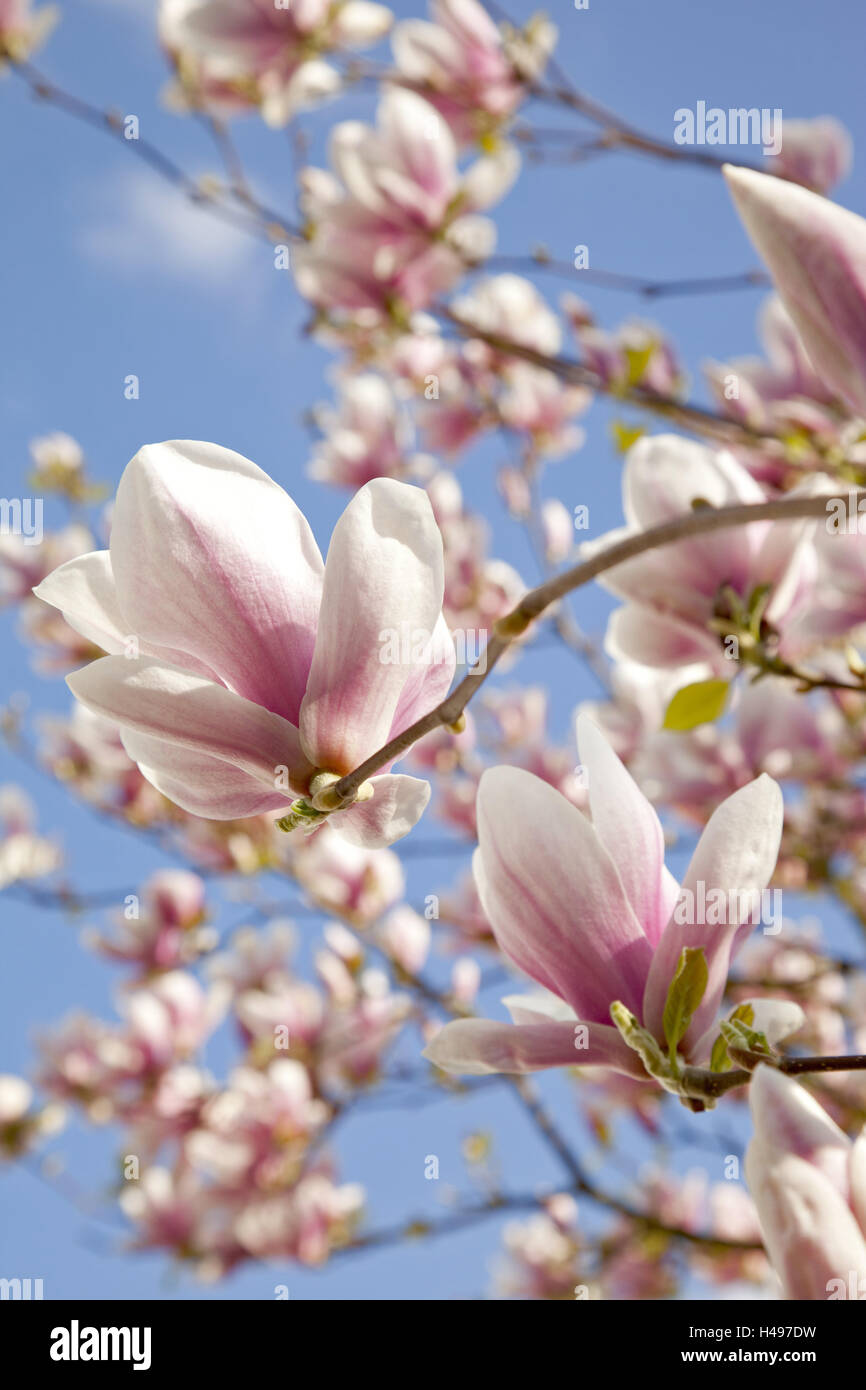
[425,717,802,1077]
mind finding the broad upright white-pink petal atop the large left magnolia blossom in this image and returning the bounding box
[111,441,322,723]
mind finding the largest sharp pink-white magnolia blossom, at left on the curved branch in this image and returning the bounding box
[36,442,455,845]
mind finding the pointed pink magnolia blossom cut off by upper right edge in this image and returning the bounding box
[724,165,866,414]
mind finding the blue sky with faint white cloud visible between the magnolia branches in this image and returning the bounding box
[0,0,866,1298]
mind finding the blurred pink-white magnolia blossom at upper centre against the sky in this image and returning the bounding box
[292,88,520,314]
